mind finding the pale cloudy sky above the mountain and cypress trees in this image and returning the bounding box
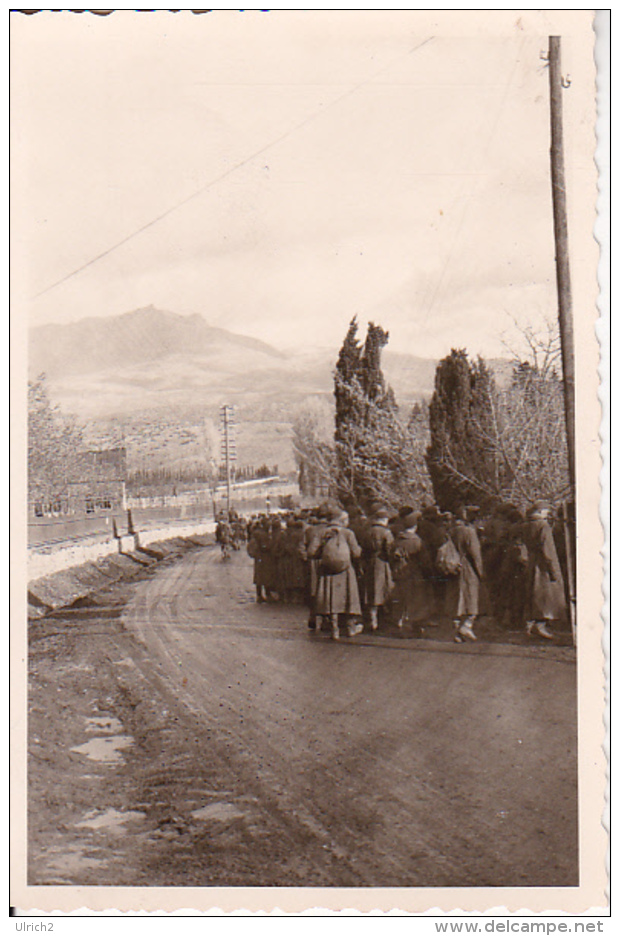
[12,11,591,357]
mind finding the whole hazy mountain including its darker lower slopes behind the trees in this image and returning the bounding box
[29,306,507,471]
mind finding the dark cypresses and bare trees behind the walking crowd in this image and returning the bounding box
[293,318,570,510]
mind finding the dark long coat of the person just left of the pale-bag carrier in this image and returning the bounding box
[393,530,435,621]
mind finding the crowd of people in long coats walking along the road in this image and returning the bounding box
[244,501,566,642]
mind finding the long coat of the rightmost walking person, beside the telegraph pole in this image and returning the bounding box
[524,519,566,621]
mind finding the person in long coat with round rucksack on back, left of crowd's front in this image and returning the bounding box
[308,506,363,640]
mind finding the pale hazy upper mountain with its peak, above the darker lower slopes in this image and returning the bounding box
[29,306,436,417]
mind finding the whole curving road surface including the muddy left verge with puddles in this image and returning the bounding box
[29,548,577,887]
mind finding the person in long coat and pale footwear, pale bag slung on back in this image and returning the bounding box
[452,507,484,643]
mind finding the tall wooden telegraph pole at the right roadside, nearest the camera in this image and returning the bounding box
[549,36,577,642]
